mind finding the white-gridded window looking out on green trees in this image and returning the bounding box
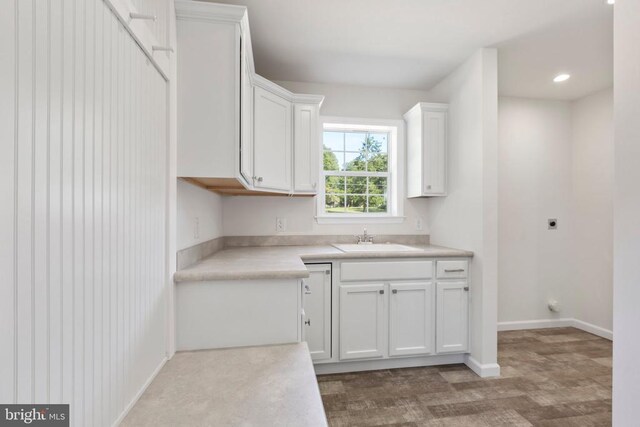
[318,121,398,219]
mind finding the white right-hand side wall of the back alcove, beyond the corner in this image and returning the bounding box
[572,89,614,331]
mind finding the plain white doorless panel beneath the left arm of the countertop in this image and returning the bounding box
[176,279,301,350]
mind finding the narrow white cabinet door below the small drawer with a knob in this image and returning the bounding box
[436,282,469,353]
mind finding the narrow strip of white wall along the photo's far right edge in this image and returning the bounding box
[613,0,640,427]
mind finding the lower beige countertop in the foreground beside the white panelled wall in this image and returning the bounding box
[122,342,327,427]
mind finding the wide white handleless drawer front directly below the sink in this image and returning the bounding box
[340,261,433,282]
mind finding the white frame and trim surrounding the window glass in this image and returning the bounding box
[316,117,405,224]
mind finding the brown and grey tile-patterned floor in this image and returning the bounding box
[318,328,611,427]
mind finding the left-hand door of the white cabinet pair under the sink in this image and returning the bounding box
[340,284,386,360]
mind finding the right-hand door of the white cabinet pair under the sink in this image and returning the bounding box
[389,282,436,356]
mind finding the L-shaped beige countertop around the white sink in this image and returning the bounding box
[174,245,473,283]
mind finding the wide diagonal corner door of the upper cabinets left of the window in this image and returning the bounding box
[253,87,293,192]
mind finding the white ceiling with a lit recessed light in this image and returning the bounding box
[211,0,613,99]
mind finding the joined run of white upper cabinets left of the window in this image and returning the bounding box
[176,0,324,195]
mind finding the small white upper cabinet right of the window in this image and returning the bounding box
[404,102,449,197]
